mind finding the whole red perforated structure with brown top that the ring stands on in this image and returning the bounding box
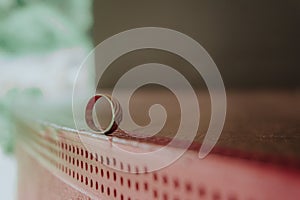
[17,91,300,200]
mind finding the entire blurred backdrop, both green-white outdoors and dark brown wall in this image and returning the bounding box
[0,0,300,200]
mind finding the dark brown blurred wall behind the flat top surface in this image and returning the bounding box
[93,0,300,89]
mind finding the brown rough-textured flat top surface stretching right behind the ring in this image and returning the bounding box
[100,91,300,161]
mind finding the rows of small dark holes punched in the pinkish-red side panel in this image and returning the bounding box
[34,128,237,200]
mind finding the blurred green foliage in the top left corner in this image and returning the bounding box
[0,0,93,54]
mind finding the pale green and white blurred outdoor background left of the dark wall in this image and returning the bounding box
[0,0,93,200]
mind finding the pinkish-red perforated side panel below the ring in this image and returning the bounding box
[18,120,300,200]
